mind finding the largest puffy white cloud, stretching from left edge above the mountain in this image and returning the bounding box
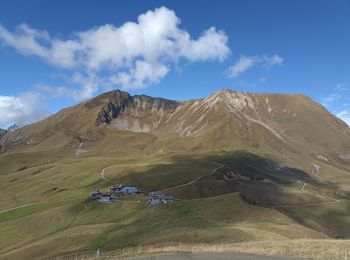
[0,7,231,97]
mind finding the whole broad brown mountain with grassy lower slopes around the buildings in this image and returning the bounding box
[0,89,350,258]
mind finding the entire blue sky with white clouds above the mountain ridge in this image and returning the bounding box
[0,0,350,128]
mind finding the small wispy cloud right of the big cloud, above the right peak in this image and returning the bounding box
[228,55,284,78]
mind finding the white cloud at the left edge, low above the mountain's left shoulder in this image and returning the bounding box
[0,92,47,127]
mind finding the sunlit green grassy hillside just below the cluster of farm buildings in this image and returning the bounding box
[0,194,323,259]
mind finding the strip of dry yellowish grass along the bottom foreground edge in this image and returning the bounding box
[43,239,350,260]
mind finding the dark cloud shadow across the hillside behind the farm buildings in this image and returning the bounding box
[93,151,327,204]
